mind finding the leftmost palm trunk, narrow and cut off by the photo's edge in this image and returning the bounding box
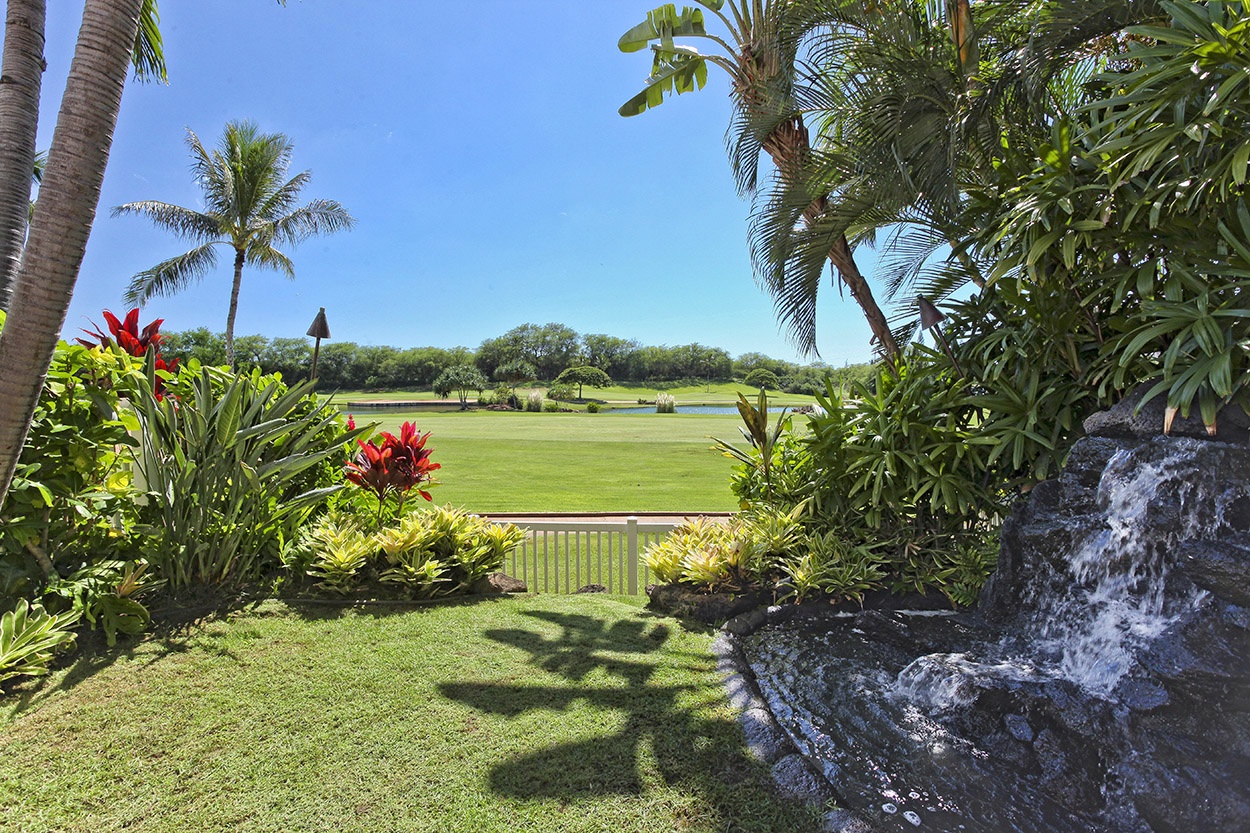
[0,0,45,309]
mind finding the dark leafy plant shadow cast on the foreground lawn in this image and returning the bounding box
[440,612,810,830]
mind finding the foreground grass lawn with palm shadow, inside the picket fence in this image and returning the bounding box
[0,595,818,833]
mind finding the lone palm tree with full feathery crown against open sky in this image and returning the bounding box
[113,121,355,366]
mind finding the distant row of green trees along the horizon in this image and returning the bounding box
[163,318,870,393]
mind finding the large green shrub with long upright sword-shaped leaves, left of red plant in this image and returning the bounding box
[135,363,365,589]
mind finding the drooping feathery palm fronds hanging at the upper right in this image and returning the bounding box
[740,0,1158,341]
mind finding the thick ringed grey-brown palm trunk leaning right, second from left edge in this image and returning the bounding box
[0,0,143,505]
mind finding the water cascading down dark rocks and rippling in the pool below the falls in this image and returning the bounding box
[743,440,1244,833]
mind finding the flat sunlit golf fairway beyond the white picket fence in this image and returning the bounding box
[337,410,745,513]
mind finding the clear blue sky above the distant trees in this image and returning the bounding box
[39,0,871,365]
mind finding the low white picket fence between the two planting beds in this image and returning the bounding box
[491,515,710,595]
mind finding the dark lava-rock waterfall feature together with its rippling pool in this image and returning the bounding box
[733,427,1250,833]
